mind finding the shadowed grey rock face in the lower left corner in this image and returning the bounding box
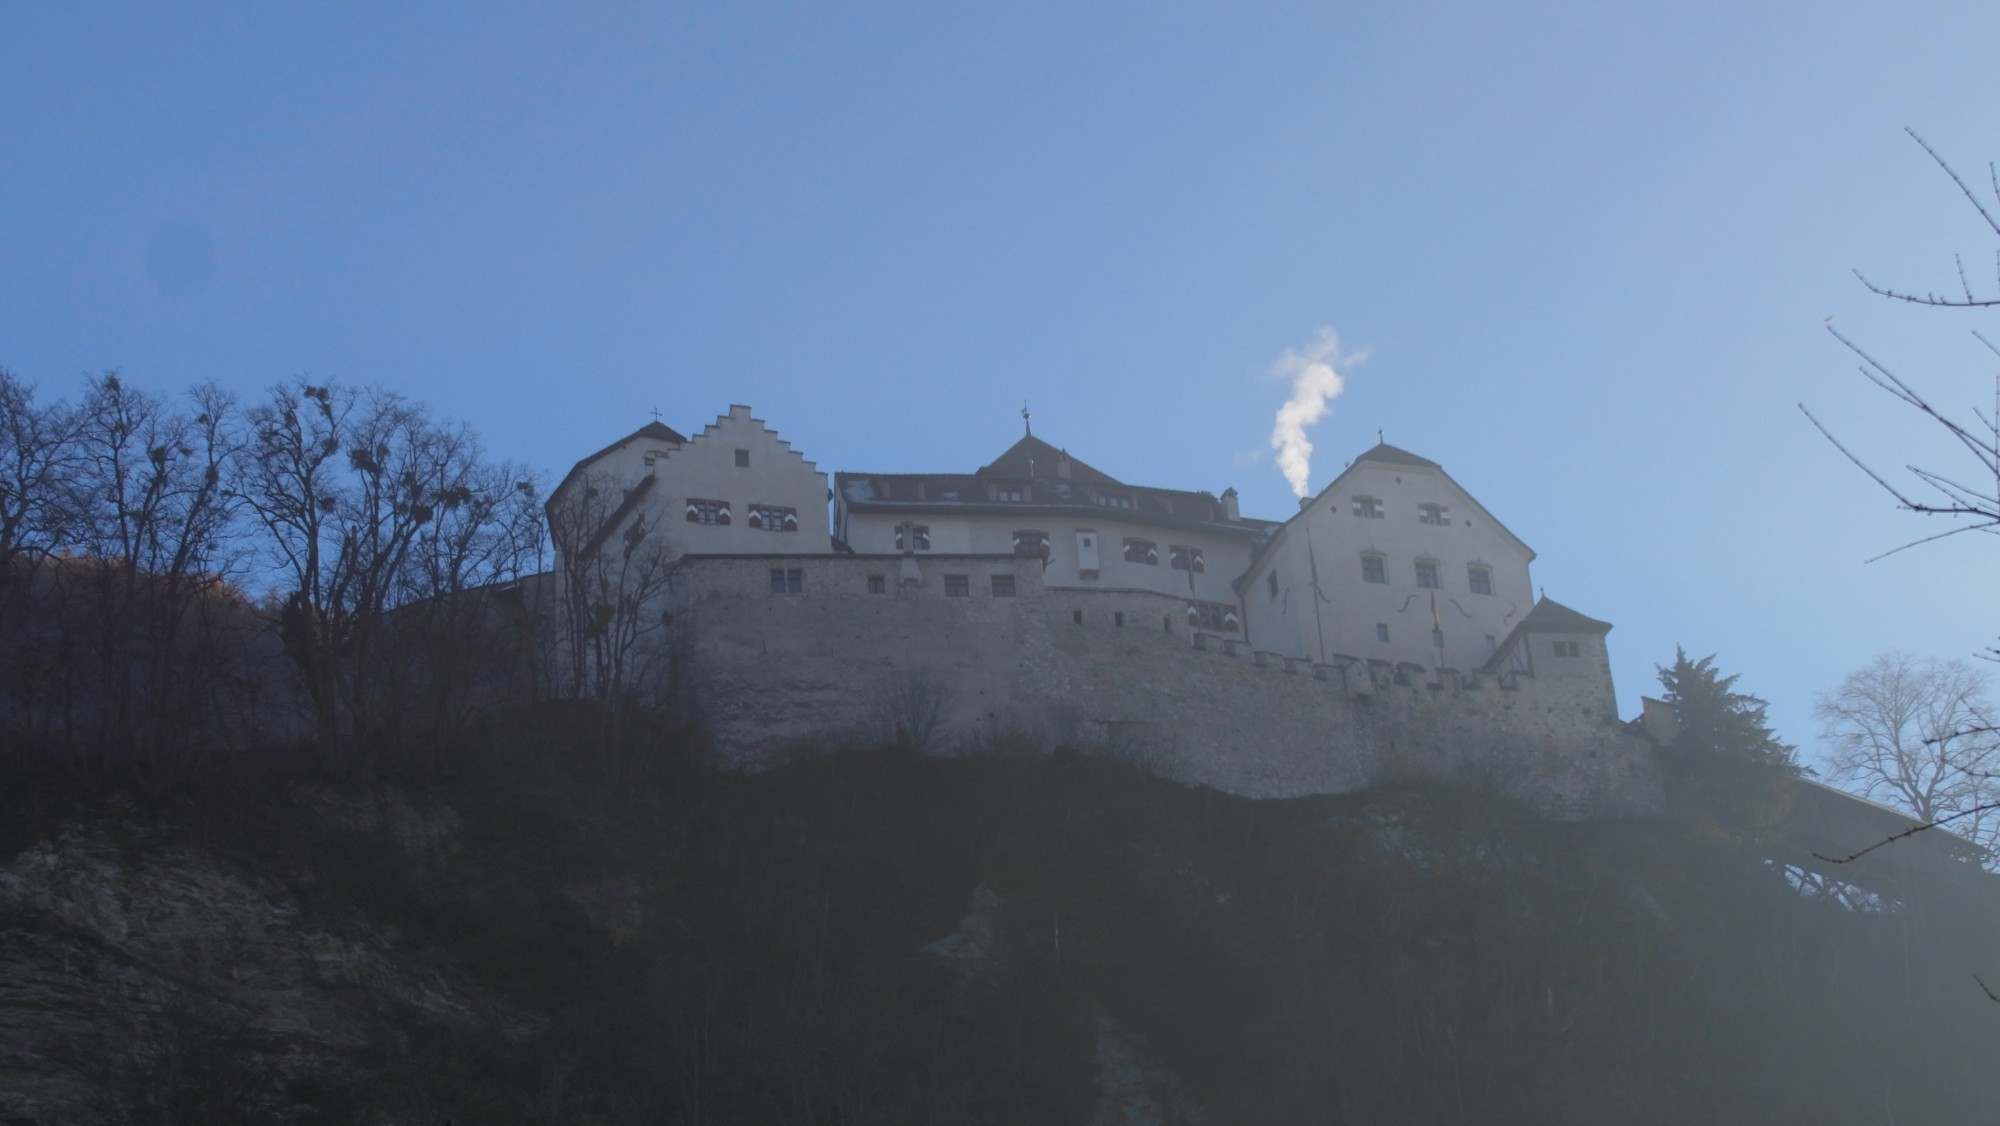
[0,802,536,1122]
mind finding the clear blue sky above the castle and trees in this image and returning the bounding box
[0,0,2000,752]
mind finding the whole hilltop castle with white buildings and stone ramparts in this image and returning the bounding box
[550,406,1658,816]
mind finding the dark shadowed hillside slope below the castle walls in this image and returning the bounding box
[0,728,2000,1124]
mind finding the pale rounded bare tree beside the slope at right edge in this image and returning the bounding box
[1814,652,2000,848]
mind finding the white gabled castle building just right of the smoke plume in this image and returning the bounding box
[1236,446,1534,672]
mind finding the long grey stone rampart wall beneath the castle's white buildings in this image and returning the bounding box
[674,556,1658,816]
